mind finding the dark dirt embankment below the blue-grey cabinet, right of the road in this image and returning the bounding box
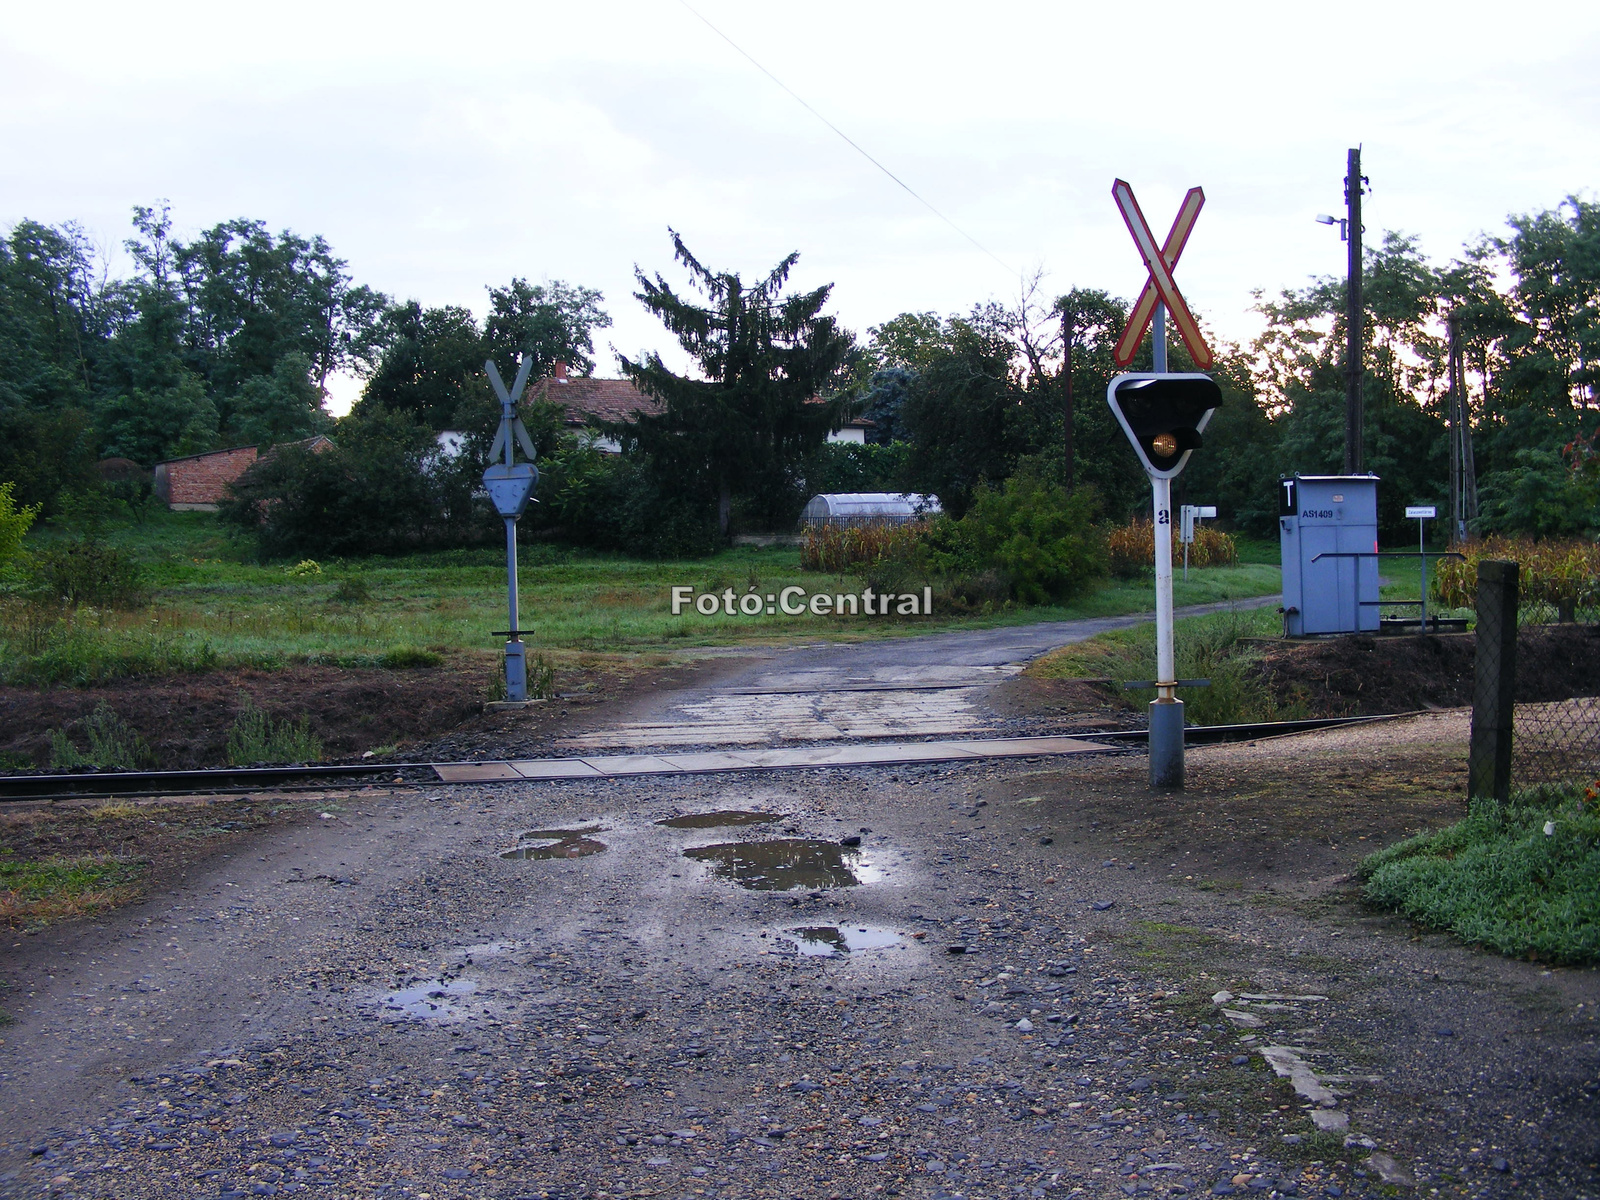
[1254,626,1600,717]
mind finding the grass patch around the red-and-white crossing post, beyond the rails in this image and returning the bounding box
[1027,608,1304,725]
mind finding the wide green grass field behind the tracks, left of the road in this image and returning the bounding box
[0,512,1280,685]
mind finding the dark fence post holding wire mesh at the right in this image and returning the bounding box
[1467,558,1518,803]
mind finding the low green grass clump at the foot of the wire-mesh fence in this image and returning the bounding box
[1360,787,1600,963]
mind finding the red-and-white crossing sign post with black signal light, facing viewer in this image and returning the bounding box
[1106,179,1222,789]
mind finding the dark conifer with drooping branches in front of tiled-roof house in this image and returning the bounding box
[616,230,854,534]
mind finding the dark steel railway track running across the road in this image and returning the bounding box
[0,712,1414,803]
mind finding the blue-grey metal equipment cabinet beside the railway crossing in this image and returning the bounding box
[1278,475,1379,637]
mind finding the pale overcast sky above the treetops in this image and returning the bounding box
[0,0,1600,403]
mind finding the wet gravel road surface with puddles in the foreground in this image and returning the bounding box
[0,720,1597,1200]
